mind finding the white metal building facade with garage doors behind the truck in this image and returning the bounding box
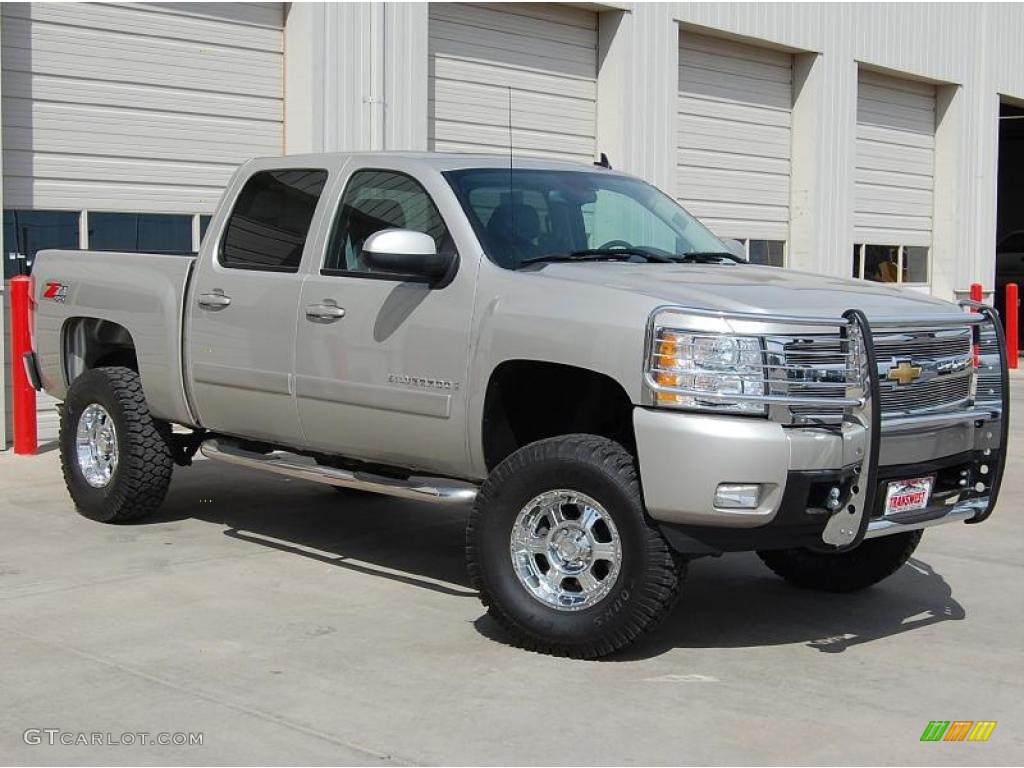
[0,2,1024,441]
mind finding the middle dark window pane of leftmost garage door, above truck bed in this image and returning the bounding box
[88,211,193,253]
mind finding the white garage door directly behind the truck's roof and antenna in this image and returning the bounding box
[429,3,597,163]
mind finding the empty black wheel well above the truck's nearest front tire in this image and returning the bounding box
[483,360,636,471]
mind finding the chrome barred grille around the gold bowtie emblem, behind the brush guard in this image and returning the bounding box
[769,327,973,419]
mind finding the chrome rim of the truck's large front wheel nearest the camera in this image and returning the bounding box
[509,489,623,610]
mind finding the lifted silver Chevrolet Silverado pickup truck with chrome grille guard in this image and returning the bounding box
[26,154,1009,657]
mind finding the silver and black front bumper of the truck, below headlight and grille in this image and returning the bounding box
[634,305,1009,553]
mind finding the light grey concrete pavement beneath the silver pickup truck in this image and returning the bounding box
[0,378,1024,765]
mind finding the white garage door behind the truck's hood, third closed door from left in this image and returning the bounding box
[677,30,793,249]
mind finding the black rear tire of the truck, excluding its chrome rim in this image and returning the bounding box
[60,368,174,523]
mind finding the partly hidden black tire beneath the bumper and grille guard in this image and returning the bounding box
[758,530,922,592]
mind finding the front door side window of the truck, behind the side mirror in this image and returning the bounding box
[324,171,451,272]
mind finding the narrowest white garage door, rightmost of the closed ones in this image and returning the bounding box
[854,71,935,247]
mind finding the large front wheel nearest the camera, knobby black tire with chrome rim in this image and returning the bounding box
[466,435,685,658]
